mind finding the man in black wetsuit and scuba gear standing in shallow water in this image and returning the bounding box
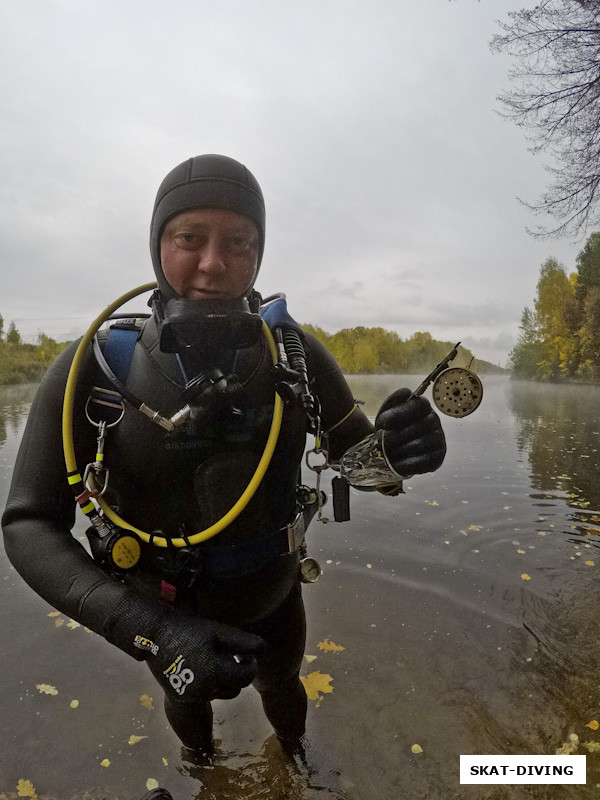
[2,155,446,764]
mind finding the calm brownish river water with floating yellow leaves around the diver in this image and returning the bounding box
[0,376,600,800]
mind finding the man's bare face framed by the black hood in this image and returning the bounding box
[160,208,258,300]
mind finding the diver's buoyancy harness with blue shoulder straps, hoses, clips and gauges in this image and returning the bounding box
[63,285,349,582]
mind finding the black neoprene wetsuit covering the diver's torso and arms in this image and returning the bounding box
[2,310,373,742]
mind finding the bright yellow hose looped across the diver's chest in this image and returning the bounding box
[62,283,283,547]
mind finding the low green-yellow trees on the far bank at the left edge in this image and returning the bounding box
[0,315,69,385]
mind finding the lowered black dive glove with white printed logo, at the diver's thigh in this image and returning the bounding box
[105,594,266,701]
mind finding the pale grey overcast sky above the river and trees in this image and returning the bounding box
[0,0,591,364]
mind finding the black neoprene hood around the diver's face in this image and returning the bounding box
[150,155,265,300]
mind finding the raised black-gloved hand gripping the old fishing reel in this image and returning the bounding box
[375,389,446,477]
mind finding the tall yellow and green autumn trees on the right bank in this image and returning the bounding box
[510,233,600,382]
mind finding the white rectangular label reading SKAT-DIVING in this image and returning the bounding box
[460,756,585,783]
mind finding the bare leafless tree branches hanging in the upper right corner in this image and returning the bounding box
[491,0,600,235]
